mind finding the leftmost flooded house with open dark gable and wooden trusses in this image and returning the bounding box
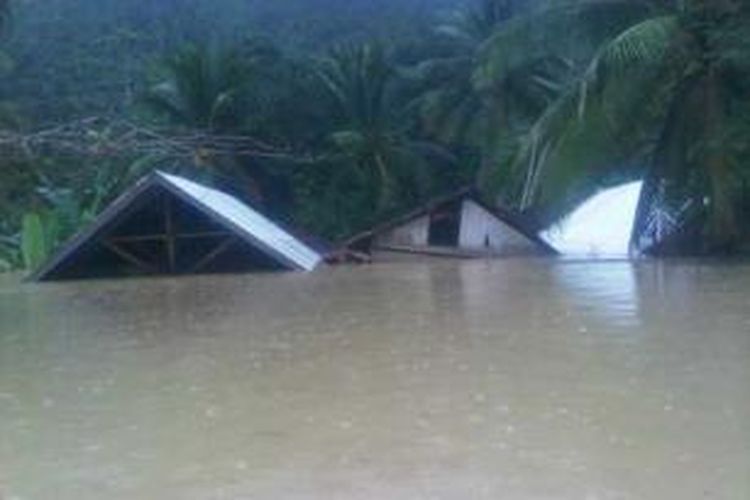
[32,172,323,281]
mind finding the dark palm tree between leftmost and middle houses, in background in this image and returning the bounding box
[317,44,447,212]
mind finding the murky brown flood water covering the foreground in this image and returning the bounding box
[0,260,750,500]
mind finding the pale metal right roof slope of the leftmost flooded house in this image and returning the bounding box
[157,172,323,271]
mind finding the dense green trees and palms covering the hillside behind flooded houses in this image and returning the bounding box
[0,0,750,269]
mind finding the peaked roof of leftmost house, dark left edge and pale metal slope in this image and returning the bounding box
[32,171,323,280]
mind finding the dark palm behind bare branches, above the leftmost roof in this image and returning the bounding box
[144,41,286,201]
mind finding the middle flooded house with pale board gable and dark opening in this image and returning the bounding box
[345,188,557,258]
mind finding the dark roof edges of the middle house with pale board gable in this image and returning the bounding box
[344,186,558,255]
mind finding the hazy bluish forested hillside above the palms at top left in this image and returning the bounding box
[4,0,468,120]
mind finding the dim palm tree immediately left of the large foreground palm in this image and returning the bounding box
[415,0,565,191]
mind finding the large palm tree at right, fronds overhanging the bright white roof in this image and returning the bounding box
[481,0,750,249]
